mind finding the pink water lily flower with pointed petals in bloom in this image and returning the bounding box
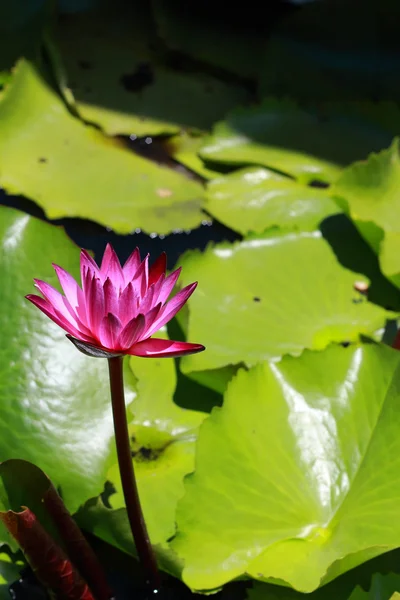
[26,244,204,357]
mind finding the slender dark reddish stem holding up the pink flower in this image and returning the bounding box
[108,356,161,593]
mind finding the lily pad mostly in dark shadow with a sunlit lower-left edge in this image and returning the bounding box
[200,99,391,182]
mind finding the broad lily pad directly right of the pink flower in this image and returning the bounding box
[179,231,388,372]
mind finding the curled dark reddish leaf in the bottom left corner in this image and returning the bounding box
[0,459,113,600]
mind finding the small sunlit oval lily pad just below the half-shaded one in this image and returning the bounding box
[206,167,340,234]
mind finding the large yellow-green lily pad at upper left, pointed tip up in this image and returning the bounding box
[0,61,204,233]
